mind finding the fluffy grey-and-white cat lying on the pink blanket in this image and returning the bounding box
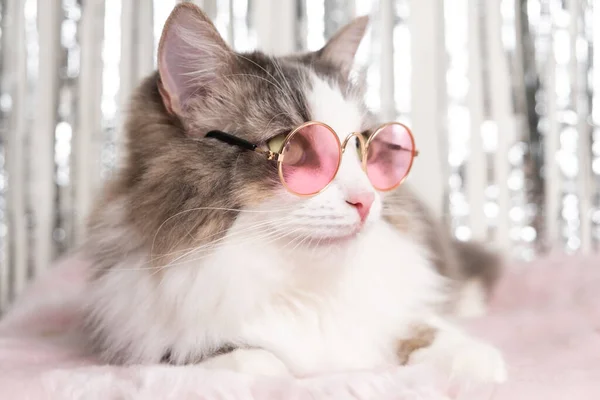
[82,3,506,382]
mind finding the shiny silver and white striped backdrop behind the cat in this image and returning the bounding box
[0,0,600,307]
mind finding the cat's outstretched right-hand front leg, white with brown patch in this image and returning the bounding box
[401,318,507,383]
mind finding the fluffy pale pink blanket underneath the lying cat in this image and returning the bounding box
[0,257,600,400]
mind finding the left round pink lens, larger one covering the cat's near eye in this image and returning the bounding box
[281,124,340,195]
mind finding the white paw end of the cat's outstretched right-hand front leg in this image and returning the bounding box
[409,337,507,383]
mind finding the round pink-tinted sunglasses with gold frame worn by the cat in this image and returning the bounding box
[206,121,419,196]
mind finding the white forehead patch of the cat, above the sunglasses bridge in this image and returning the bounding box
[306,75,362,140]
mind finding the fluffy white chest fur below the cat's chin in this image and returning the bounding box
[85,222,441,374]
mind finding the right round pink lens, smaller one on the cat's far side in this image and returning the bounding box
[367,124,414,190]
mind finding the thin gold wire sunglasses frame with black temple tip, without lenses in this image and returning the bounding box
[206,121,419,197]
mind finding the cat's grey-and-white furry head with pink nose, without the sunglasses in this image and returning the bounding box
[107,3,396,264]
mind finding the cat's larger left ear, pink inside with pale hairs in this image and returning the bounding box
[158,3,234,115]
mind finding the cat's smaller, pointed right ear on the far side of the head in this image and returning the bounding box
[318,15,369,71]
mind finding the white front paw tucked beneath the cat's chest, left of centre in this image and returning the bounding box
[201,349,291,376]
